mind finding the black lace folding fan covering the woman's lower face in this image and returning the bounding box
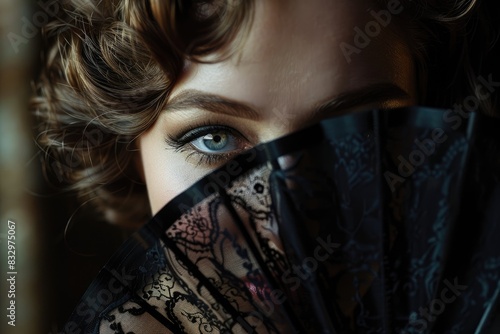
[61,108,500,334]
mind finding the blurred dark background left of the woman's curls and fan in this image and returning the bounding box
[0,0,126,334]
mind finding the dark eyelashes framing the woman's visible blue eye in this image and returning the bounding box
[165,122,245,166]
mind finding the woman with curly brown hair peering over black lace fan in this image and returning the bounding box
[34,0,499,332]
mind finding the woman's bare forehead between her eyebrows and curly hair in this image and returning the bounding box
[172,0,412,110]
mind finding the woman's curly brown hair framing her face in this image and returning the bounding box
[31,0,496,225]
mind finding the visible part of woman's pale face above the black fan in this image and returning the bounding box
[139,0,416,214]
